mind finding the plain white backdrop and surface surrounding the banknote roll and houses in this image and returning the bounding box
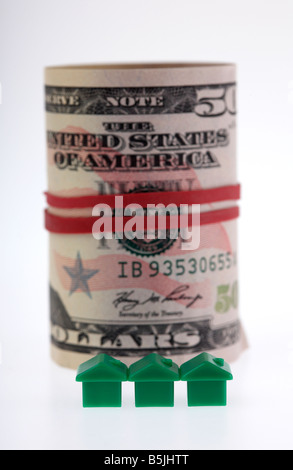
[0,0,293,450]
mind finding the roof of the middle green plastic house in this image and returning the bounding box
[128,353,179,382]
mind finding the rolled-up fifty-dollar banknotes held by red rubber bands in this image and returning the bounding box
[45,64,246,368]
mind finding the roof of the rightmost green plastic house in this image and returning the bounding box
[180,352,233,381]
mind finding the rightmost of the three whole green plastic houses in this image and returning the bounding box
[180,352,233,406]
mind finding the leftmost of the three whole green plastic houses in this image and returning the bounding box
[76,354,128,407]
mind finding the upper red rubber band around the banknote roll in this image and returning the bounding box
[45,184,240,209]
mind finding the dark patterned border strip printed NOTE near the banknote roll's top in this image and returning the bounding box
[45,82,236,117]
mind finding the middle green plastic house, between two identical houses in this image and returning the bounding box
[128,353,179,407]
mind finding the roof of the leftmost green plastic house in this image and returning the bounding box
[76,354,128,382]
